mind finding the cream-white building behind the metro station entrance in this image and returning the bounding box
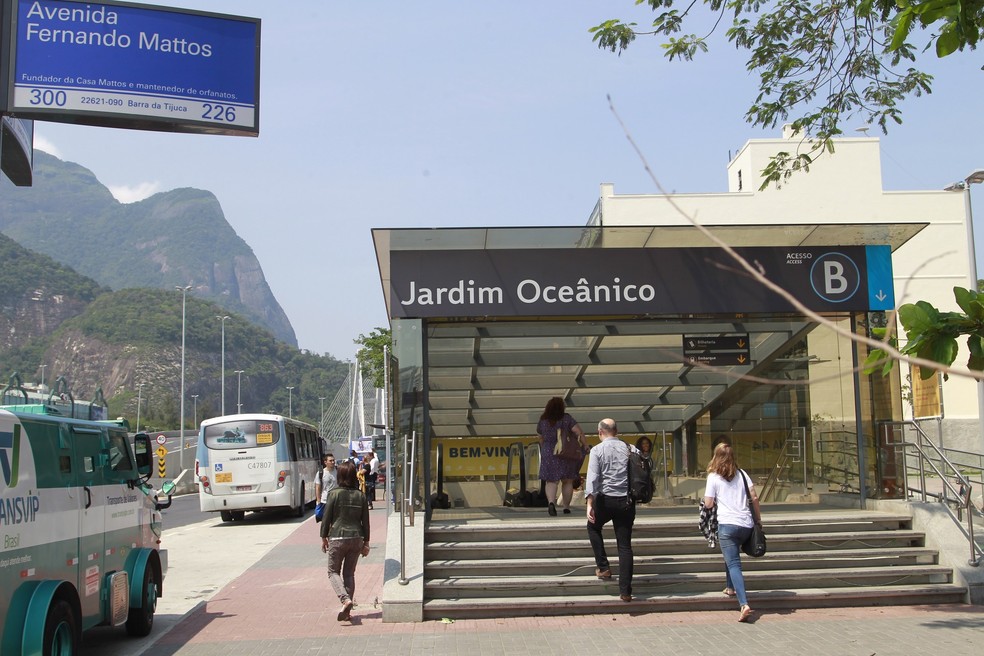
[591,135,984,452]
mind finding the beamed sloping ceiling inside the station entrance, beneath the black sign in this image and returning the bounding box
[427,320,809,437]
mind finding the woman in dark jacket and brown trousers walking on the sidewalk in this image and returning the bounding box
[321,462,369,622]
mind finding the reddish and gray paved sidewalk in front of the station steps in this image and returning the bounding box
[143,509,984,656]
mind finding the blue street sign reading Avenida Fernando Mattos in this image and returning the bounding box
[3,0,260,136]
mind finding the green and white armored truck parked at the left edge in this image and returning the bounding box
[0,403,173,656]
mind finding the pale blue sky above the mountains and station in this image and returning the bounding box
[35,0,984,360]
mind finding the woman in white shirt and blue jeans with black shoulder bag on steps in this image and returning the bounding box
[704,442,762,622]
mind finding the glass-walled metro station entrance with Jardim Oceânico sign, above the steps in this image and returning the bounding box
[374,225,919,510]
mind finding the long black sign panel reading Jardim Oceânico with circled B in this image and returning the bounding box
[390,246,894,318]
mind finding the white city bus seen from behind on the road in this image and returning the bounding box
[195,414,324,522]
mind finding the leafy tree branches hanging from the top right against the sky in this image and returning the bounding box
[590,0,984,188]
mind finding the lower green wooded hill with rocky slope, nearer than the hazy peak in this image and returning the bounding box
[0,235,348,429]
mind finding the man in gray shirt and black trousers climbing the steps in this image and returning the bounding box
[584,419,635,601]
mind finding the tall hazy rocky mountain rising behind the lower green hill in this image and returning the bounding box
[0,151,297,347]
